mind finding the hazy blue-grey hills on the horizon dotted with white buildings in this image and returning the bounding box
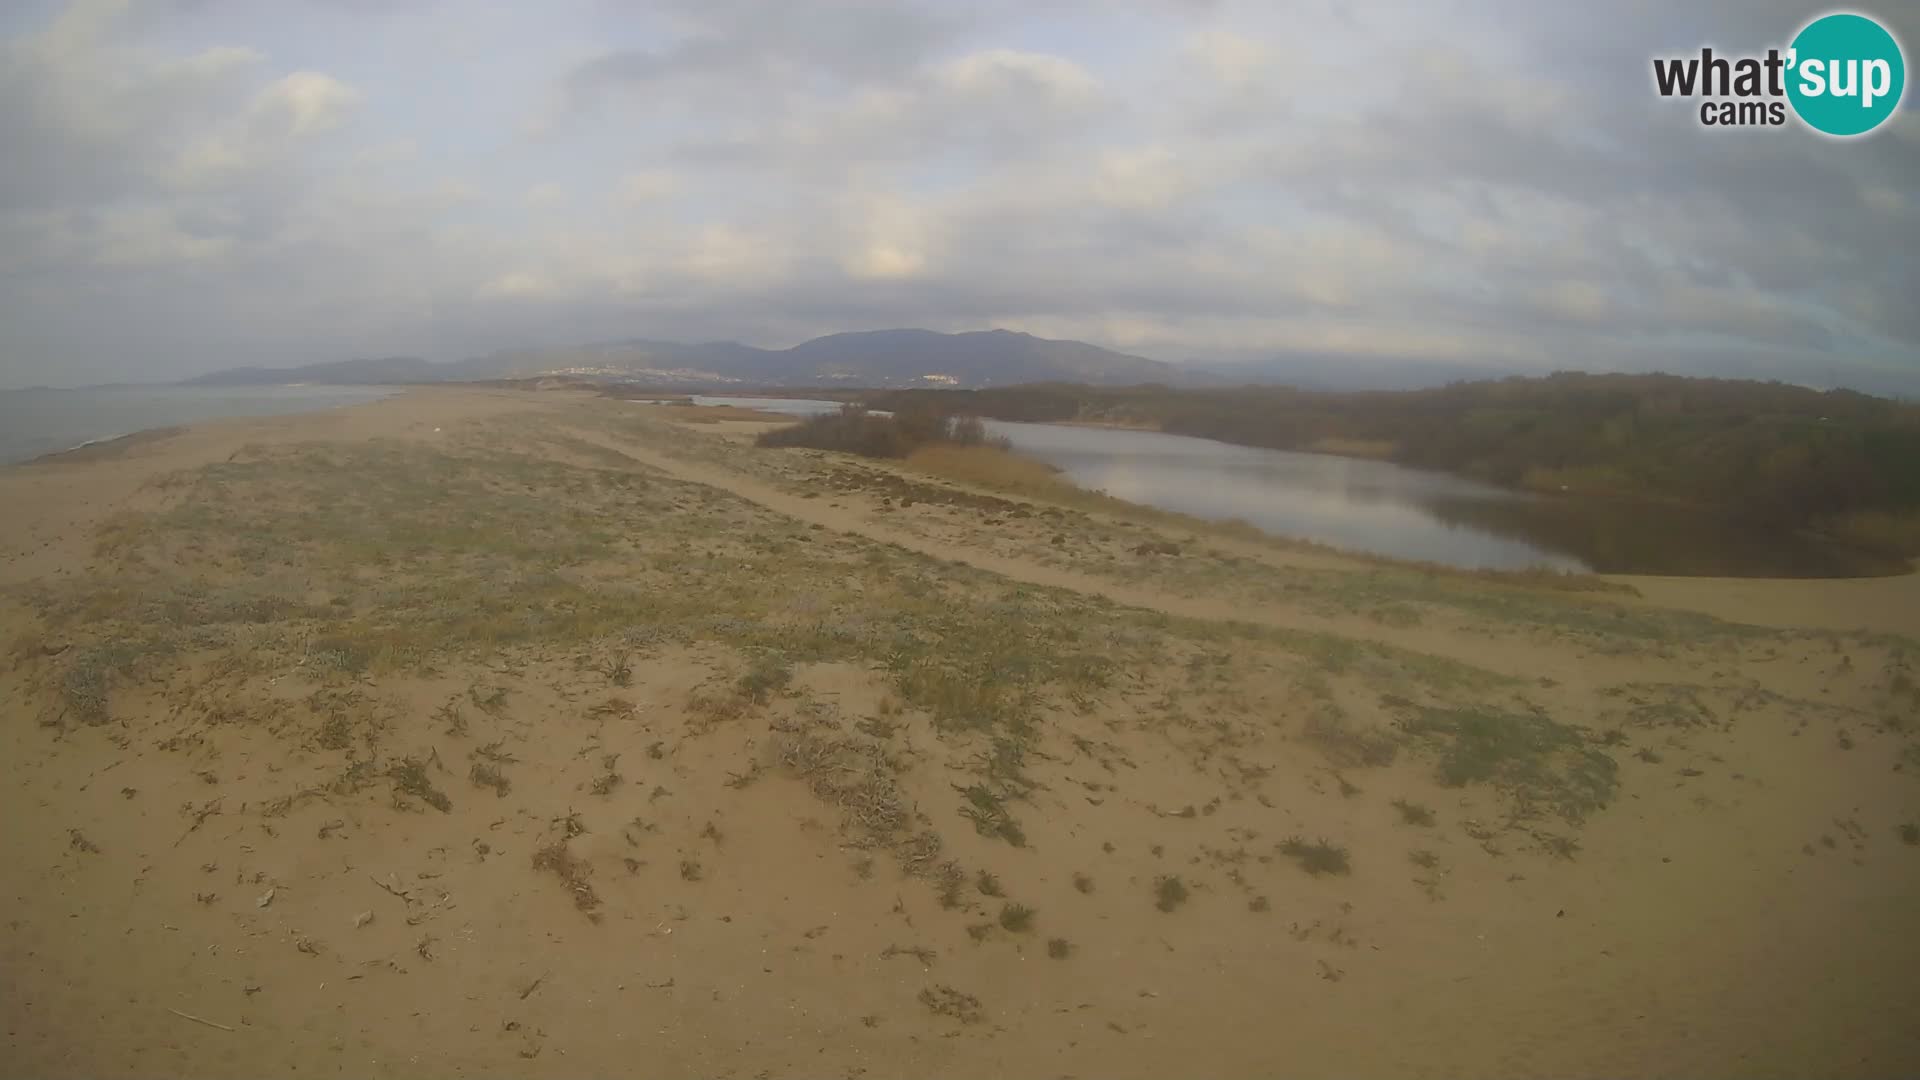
[186,331,1219,388]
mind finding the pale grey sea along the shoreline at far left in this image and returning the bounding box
[0,386,394,463]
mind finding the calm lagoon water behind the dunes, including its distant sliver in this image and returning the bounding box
[714,398,1899,577]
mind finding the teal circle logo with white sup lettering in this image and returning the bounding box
[1788,12,1907,136]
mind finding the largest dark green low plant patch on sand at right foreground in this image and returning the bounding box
[1405,709,1619,822]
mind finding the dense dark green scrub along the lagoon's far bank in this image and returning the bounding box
[868,373,1920,553]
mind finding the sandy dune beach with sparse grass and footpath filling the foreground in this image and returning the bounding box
[0,390,1920,1078]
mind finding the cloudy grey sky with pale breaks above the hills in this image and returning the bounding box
[0,0,1920,392]
